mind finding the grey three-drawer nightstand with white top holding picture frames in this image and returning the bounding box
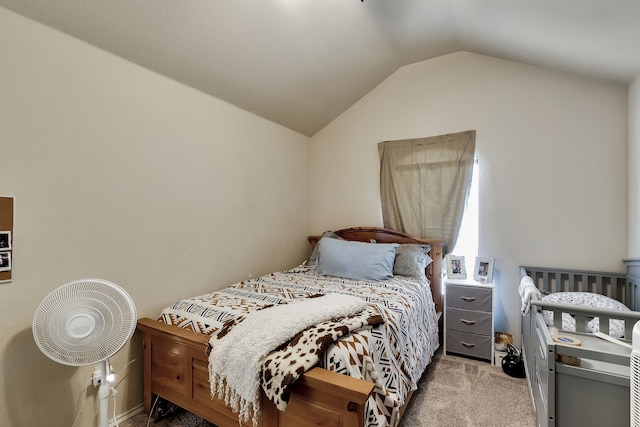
[444,279,495,364]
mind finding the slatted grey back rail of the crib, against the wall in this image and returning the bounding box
[520,266,636,309]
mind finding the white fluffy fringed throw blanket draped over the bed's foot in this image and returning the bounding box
[209,294,366,425]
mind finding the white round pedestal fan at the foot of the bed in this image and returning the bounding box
[33,279,136,427]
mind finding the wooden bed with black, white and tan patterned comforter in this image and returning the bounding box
[138,227,443,427]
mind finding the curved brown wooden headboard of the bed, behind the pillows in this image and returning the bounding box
[309,227,444,313]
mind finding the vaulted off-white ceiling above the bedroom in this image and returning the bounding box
[0,0,640,135]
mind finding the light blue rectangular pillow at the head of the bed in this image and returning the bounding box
[316,239,398,281]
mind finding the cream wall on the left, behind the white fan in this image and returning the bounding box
[0,8,309,427]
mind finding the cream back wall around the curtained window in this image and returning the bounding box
[311,52,628,342]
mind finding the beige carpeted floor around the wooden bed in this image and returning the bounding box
[120,351,536,427]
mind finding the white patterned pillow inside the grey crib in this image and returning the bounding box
[542,292,631,338]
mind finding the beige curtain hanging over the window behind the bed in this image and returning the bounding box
[378,131,476,250]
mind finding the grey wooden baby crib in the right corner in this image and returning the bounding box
[519,267,640,427]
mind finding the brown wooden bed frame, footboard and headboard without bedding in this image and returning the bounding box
[138,227,443,427]
